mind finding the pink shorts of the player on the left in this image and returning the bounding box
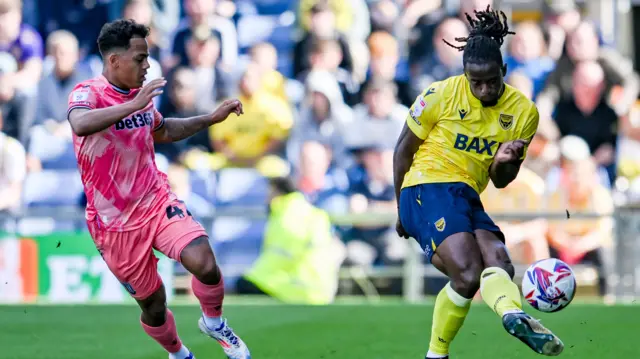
[88,201,207,299]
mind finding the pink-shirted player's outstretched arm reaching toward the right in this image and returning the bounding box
[153,100,244,143]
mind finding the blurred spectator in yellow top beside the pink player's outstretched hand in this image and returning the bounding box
[187,63,293,176]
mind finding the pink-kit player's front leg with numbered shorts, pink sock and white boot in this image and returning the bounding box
[155,201,251,359]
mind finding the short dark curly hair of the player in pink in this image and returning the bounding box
[98,19,149,56]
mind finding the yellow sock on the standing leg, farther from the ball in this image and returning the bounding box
[427,283,471,357]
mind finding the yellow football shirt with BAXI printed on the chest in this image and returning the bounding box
[402,75,539,193]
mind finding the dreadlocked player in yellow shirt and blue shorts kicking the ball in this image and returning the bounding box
[394,7,564,359]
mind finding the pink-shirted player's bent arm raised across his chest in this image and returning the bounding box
[69,78,167,137]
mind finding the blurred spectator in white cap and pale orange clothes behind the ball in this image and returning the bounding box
[546,136,613,294]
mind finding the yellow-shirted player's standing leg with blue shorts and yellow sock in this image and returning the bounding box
[400,184,483,359]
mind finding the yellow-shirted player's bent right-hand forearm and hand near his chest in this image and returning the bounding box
[489,140,528,188]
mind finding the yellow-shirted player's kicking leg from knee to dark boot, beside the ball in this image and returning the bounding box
[475,231,564,356]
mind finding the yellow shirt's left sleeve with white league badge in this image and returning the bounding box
[406,87,441,140]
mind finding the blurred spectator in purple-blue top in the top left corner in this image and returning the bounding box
[0,0,44,93]
